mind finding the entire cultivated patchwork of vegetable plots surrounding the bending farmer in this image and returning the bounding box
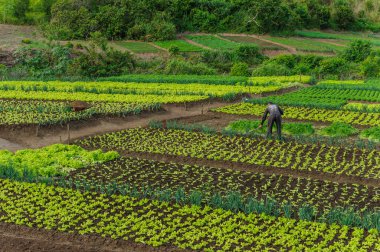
[0,76,380,251]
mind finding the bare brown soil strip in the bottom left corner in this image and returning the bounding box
[0,223,184,252]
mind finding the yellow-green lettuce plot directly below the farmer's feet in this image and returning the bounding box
[78,128,380,179]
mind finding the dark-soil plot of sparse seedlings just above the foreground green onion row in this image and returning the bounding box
[69,158,380,212]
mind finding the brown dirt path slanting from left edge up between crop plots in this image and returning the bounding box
[0,102,231,151]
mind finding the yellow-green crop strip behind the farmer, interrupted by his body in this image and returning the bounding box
[214,103,380,126]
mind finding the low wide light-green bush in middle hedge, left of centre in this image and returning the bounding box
[164,59,216,75]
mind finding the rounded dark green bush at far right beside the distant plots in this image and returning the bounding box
[343,40,372,62]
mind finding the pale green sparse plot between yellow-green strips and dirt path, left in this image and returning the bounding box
[0,100,160,125]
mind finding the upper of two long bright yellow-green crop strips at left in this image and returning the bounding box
[0,81,287,99]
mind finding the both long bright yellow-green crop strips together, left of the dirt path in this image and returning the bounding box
[0,81,292,103]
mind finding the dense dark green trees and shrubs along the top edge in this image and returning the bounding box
[0,0,378,40]
